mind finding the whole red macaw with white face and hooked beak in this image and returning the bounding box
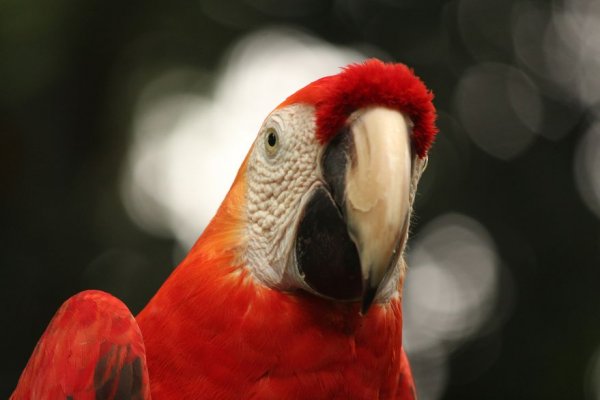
[11,60,437,400]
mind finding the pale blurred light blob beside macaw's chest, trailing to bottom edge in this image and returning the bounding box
[403,213,501,399]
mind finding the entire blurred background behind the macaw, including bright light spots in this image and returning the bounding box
[0,0,600,400]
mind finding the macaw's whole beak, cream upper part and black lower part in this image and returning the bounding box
[296,107,412,313]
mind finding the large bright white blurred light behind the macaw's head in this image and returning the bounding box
[121,28,365,248]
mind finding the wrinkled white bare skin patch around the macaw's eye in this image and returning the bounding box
[245,105,321,289]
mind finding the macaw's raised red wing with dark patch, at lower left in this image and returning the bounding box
[10,290,150,400]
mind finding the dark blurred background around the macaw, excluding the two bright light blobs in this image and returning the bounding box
[0,0,600,400]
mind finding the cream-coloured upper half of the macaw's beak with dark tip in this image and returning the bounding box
[344,108,411,308]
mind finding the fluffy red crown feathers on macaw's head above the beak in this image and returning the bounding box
[278,59,438,158]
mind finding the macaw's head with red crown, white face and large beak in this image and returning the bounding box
[199,60,437,313]
